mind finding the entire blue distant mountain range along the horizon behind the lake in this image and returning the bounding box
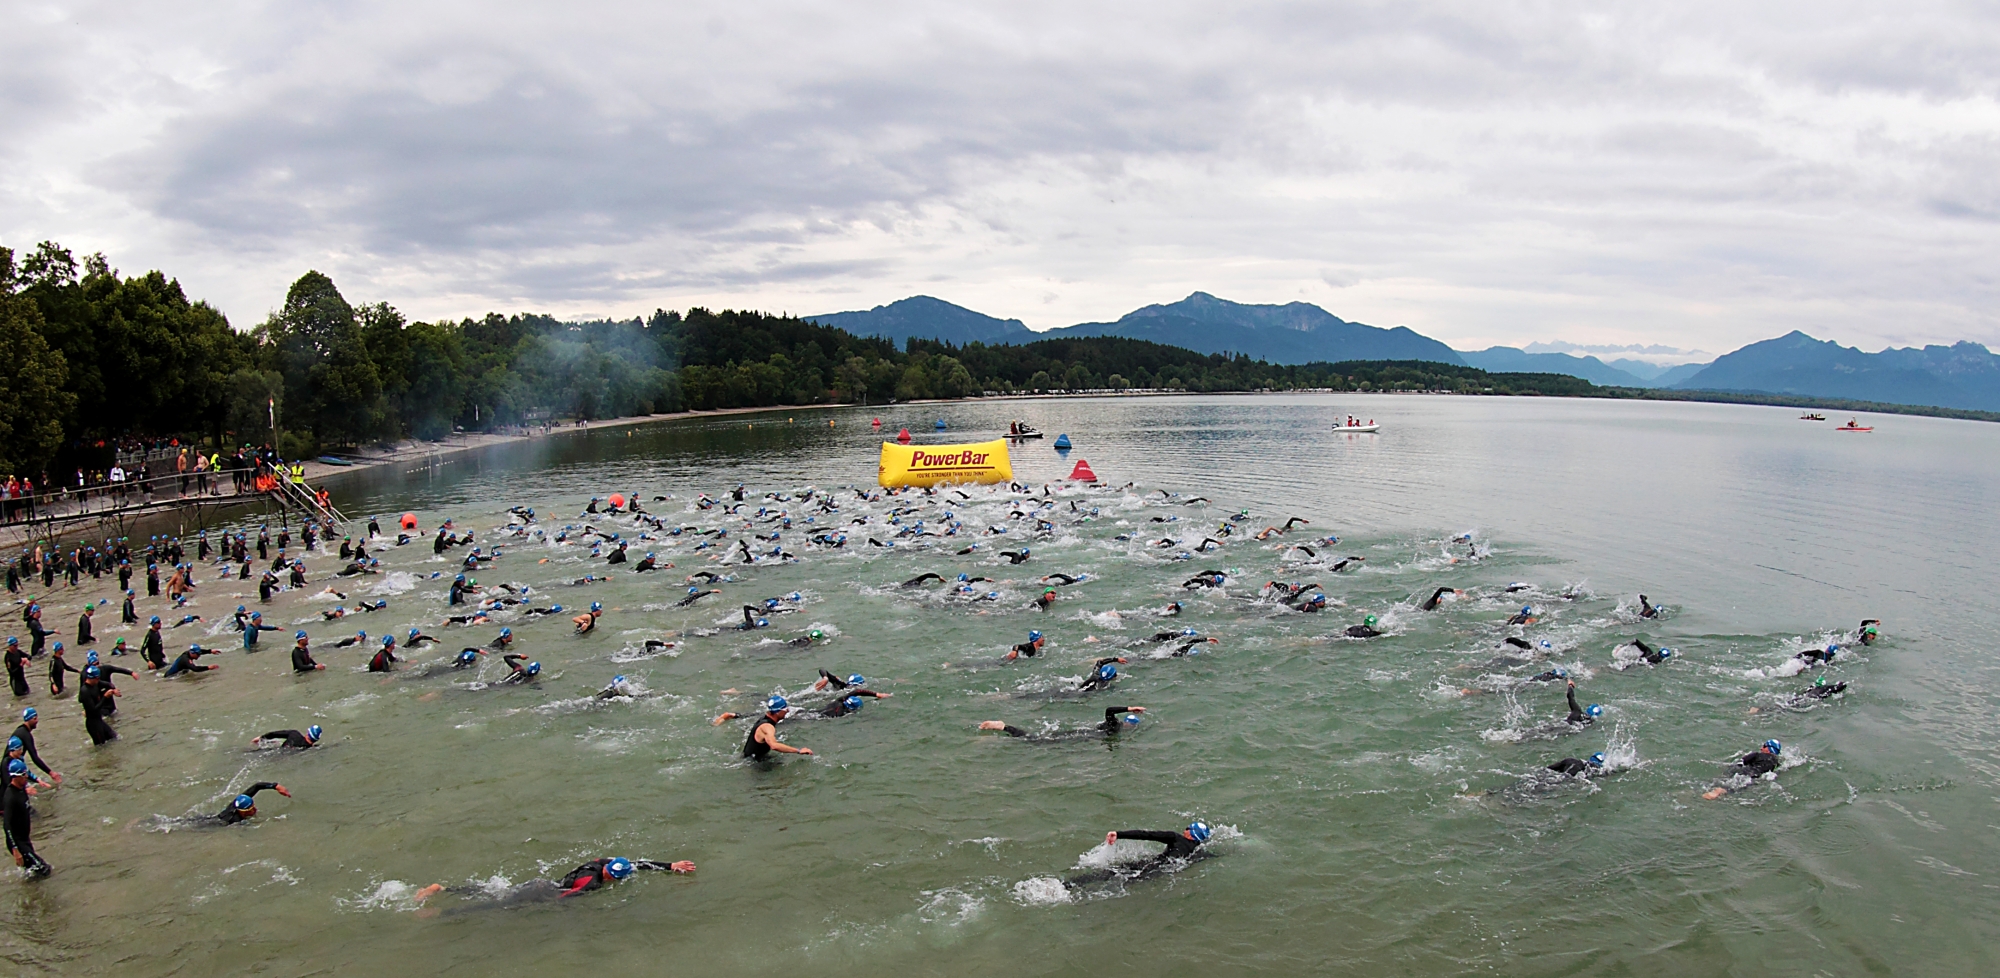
[806,292,2000,410]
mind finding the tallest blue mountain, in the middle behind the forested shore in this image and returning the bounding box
[1042,292,1464,364]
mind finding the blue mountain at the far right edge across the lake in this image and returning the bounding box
[1674,330,2000,410]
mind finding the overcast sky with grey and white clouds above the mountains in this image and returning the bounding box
[0,0,2000,358]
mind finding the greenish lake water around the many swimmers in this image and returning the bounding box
[0,396,2000,978]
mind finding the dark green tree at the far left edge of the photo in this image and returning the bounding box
[0,248,76,474]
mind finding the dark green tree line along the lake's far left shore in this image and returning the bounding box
[0,242,1604,474]
